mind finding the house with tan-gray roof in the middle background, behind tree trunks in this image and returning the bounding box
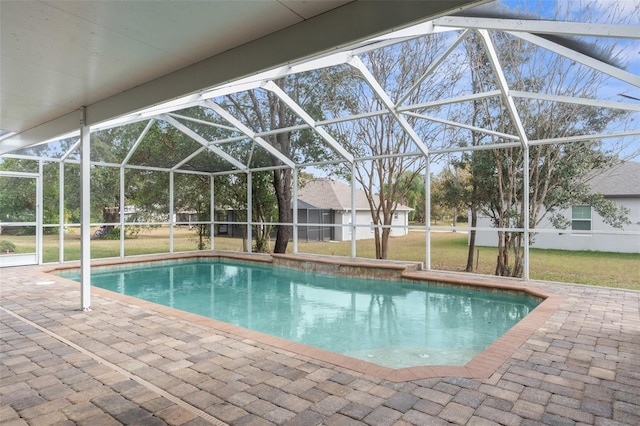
[298,178,412,241]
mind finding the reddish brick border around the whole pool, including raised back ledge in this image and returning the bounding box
[42,251,565,382]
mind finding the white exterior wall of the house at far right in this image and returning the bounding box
[476,198,640,253]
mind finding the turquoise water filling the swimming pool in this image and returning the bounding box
[61,259,539,368]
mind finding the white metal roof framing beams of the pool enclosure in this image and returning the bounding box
[2,12,640,172]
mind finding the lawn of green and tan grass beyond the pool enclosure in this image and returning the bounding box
[0,228,640,290]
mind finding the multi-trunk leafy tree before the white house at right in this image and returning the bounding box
[467,28,625,277]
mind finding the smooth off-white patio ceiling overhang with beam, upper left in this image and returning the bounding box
[0,0,488,154]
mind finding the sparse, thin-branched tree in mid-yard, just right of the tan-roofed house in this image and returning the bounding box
[329,35,458,259]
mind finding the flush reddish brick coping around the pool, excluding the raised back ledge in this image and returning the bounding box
[41,253,566,382]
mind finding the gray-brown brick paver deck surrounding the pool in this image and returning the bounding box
[0,267,640,426]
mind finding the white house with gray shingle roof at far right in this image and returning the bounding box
[476,161,640,253]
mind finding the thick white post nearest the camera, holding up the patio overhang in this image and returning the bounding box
[80,107,91,311]
